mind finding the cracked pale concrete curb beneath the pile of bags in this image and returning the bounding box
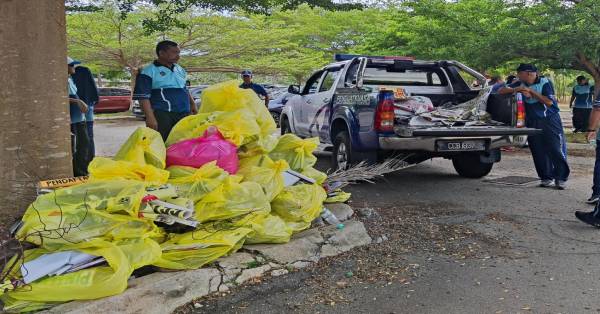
[43,204,372,314]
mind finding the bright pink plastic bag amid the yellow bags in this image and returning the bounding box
[167,127,239,174]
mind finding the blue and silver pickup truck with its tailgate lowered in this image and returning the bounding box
[280,55,539,178]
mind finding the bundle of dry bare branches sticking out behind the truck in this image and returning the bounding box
[324,158,412,188]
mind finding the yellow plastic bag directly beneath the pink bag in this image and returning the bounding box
[167,161,229,203]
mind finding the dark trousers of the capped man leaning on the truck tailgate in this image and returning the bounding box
[527,113,570,181]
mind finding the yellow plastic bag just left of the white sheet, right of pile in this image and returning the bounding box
[238,155,290,201]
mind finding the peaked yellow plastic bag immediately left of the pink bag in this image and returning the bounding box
[115,127,167,169]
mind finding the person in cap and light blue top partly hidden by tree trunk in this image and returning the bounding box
[67,57,90,177]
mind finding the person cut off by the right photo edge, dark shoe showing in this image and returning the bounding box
[575,98,600,228]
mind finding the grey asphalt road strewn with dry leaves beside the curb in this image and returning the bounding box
[96,116,600,313]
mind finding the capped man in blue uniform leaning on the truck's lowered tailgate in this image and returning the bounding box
[499,63,570,190]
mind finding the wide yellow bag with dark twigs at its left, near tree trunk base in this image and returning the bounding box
[16,180,162,247]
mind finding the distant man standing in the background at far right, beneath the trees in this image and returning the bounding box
[569,75,594,132]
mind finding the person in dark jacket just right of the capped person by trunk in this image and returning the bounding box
[71,64,100,163]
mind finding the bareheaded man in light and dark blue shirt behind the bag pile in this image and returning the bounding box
[133,40,197,141]
